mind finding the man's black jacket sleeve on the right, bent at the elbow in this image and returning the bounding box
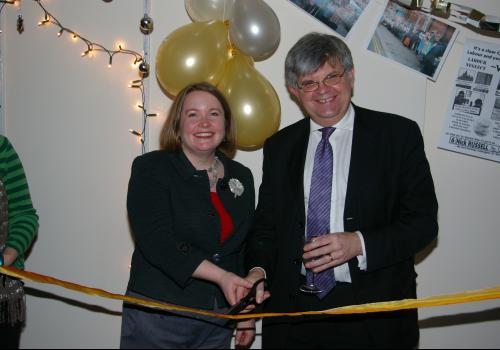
[361,122,438,272]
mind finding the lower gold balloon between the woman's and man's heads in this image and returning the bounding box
[218,52,281,149]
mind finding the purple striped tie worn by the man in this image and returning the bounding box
[306,127,335,299]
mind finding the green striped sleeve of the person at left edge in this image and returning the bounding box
[0,136,38,268]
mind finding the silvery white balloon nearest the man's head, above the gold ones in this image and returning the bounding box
[229,0,281,60]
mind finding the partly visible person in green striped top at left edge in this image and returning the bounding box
[0,135,38,349]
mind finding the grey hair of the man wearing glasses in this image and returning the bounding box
[285,32,354,88]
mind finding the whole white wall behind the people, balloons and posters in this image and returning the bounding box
[2,0,500,348]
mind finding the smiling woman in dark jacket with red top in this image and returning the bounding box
[120,83,255,348]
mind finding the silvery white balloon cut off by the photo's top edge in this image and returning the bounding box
[184,0,234,22]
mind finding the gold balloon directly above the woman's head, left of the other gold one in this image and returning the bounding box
[156,21,230,96]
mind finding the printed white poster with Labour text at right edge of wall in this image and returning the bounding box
[439,39,500,162]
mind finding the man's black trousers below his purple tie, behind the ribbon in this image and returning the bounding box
[262,283,373,349]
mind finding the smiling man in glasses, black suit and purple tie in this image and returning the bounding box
[240,33,438,349]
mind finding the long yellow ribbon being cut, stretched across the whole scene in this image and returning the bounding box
[0,266,500,319]
